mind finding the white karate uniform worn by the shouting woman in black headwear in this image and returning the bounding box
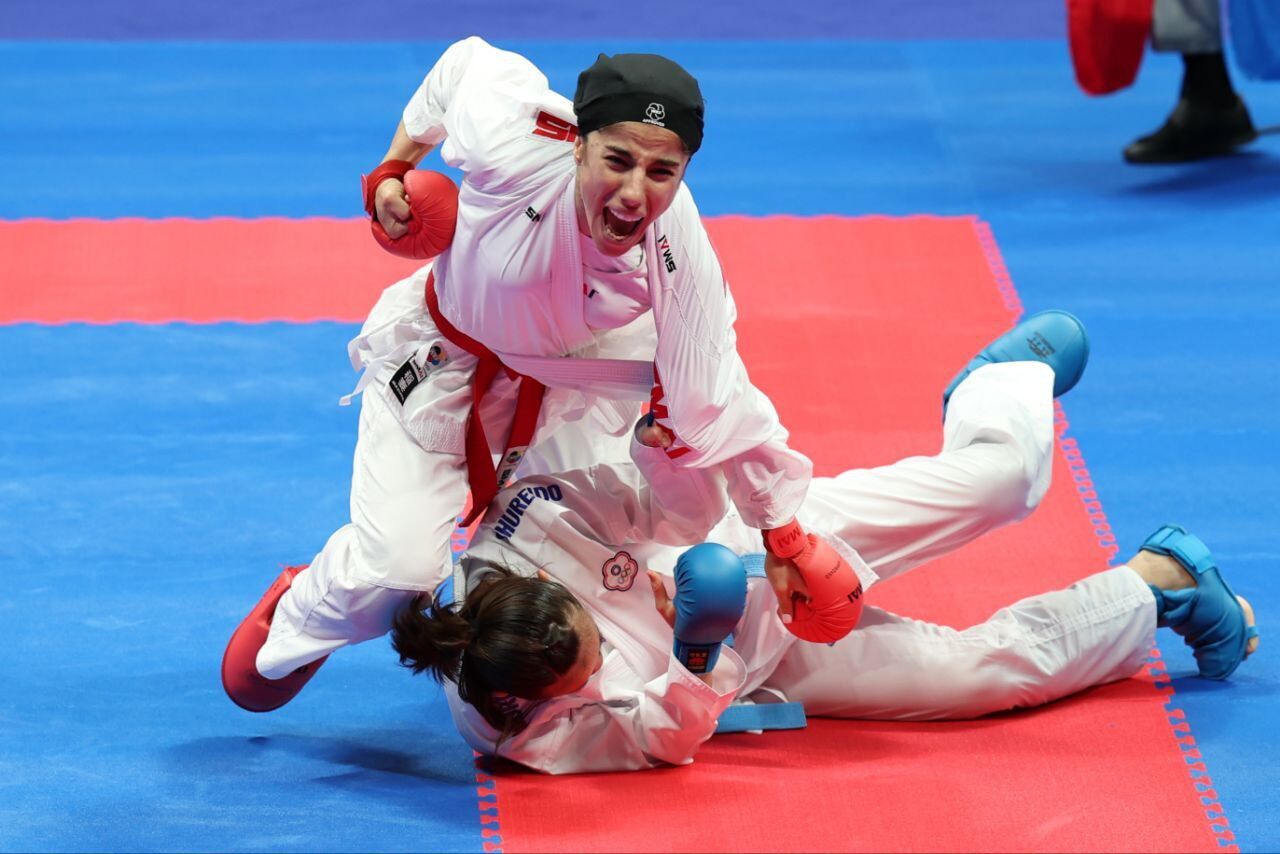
[257,38,812,679]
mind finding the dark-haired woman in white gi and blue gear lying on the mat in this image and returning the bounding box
[392,315,1257,773]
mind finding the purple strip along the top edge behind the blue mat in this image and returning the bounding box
[0,0,1065,41]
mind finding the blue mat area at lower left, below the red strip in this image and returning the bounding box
[0,324,481,851]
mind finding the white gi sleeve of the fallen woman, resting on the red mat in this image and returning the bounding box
[498,649,745,773]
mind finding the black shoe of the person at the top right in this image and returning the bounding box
[1124,97,1258,163]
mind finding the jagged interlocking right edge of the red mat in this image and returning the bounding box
[972,216,1240,853]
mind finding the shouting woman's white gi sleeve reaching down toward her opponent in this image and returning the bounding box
[653,188,813,528]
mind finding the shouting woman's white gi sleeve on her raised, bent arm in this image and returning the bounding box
[403,36,572,192]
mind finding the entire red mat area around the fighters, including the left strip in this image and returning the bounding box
[0,218,1219,851]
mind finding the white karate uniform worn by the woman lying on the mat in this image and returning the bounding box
[447,362,1156,773]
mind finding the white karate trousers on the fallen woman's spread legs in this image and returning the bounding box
[764,362,1156,721]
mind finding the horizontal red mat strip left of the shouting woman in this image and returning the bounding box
[0,219,417,323]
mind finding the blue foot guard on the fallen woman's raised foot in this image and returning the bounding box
[942,309,1089,408]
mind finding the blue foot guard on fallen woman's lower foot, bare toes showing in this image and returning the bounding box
[1142,525,1258,679]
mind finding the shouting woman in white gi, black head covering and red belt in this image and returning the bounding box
[223,38,852,712]
